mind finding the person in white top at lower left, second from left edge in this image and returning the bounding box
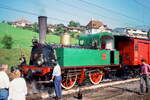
[8,69,27,100]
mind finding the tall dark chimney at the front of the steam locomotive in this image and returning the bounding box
[38,16,47,44]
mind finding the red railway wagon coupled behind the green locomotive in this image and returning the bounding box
[115,36,150,66]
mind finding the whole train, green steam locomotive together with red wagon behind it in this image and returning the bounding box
[18,16,150,89]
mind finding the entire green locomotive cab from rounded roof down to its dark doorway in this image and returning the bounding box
[79,32,119,65]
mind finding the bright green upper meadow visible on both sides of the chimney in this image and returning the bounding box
[0,23,77,48]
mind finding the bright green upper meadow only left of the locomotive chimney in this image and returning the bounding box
[0,23,38,48]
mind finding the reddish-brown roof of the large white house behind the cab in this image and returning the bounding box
[86,20,103,28]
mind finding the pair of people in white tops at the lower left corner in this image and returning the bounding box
[0,64,27,100]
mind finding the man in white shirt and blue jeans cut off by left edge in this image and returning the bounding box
[0,64,9,100]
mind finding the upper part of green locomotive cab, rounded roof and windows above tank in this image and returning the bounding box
[79,33,114,50]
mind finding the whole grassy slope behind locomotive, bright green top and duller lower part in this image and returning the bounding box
[0,23,77,66]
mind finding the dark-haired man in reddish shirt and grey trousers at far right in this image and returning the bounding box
[140,59,150,95]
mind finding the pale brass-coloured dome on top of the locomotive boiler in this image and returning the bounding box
[60,33,70,46]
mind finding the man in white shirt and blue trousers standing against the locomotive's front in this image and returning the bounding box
[51,60,62,100]
